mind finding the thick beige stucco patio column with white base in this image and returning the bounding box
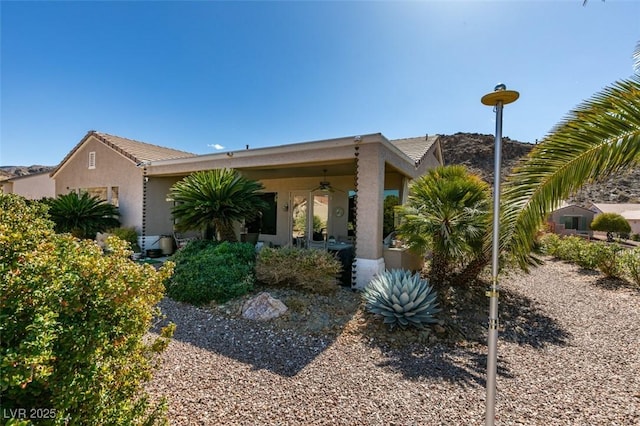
[353,144,385,288]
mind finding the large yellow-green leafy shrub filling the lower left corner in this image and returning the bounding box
[0,195,172,425]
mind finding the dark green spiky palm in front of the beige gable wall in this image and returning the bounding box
[46,192,120,238]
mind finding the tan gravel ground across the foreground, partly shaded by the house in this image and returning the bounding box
[147,261,640,425]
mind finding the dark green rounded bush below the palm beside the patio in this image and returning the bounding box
[167,240,256,305]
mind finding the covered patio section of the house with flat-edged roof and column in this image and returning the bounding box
[139,133,443,288]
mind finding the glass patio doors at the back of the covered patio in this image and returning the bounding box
[289,191,330,247]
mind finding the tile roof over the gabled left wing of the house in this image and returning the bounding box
[51,130,196,176]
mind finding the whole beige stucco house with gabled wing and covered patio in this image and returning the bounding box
[52,131,444,288]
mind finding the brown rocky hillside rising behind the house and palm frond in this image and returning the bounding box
[442,133,640,206]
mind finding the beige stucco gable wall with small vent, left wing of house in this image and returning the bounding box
[54,136,143,232]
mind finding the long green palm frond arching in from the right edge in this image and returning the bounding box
[500,74,640,269]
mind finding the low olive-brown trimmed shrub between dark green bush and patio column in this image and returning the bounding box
[256,248,342,293]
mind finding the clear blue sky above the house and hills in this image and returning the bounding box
[0,0,640,165]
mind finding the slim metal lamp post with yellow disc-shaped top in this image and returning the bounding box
[480,84,520,426]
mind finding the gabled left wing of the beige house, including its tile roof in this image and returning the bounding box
[51,130,194,231]
